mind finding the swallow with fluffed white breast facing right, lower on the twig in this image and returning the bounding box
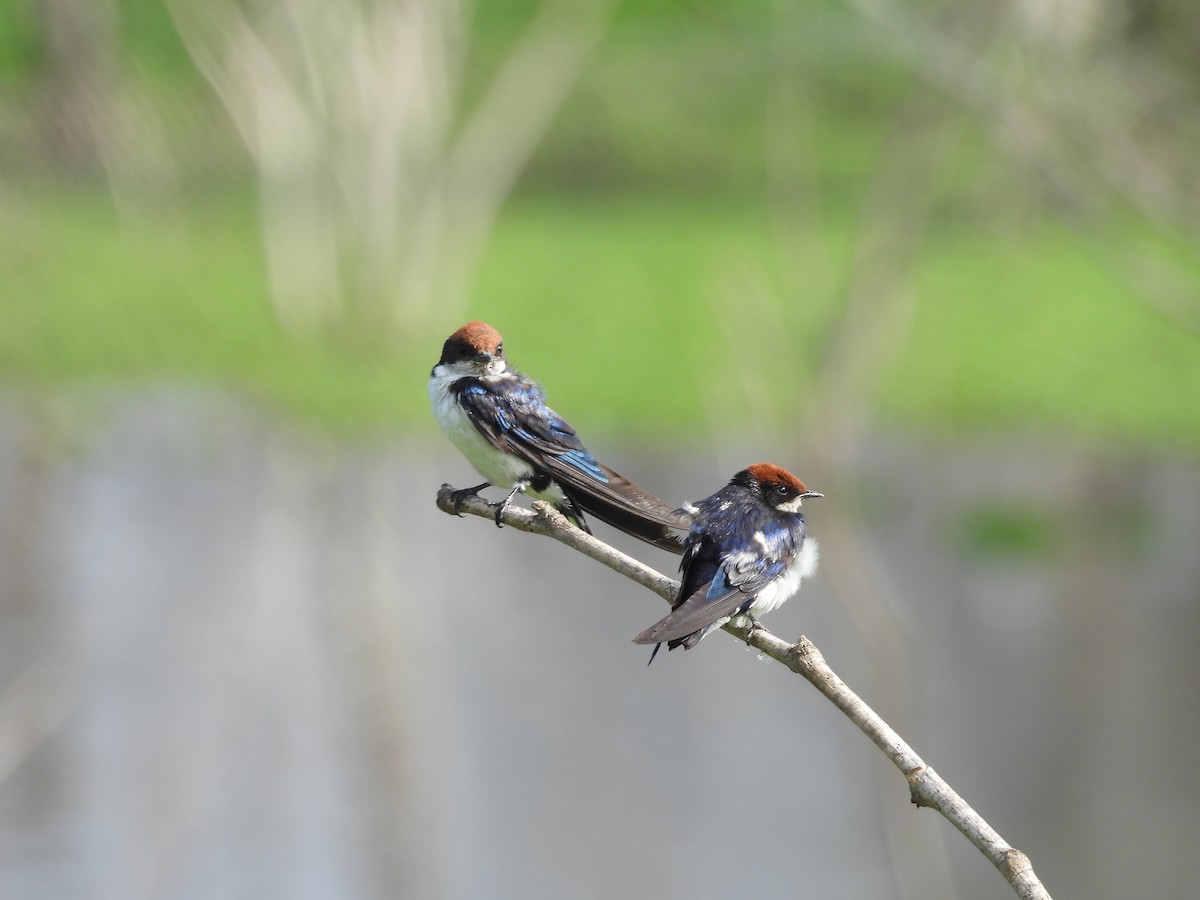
[634,462,822,662]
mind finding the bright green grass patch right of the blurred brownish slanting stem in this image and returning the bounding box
[897,221,1200,448]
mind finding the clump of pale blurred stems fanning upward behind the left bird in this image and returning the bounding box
[168,0,614,341]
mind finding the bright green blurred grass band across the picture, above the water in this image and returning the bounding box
[0,184,1200,450]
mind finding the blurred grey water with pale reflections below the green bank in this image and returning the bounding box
[0,390,1200,900]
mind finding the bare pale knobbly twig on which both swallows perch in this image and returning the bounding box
[438,485,1051,900]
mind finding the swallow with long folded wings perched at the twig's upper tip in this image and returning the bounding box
[428,322,690,553]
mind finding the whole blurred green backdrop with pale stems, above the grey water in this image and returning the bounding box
[7,0,1200,454]
